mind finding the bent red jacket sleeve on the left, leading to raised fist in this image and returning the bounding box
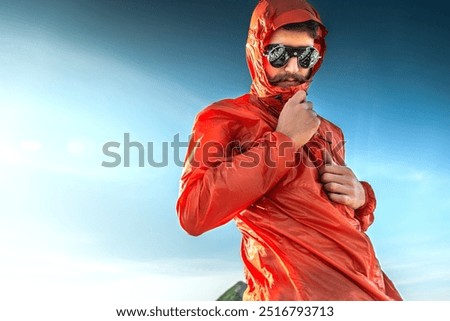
[176,105,295,236]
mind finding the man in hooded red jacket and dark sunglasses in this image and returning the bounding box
[177,0,401,300]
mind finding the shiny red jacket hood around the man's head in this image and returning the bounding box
[246,0,327,100]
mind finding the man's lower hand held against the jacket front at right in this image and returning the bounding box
[319,150,366,210]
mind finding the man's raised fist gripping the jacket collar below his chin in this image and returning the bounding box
[276,90,320,149]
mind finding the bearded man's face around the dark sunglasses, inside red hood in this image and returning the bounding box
[264,28,314,88]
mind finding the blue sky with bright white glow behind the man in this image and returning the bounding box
[0,0,450,304]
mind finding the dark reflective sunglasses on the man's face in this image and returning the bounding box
[263,44,322,69]
